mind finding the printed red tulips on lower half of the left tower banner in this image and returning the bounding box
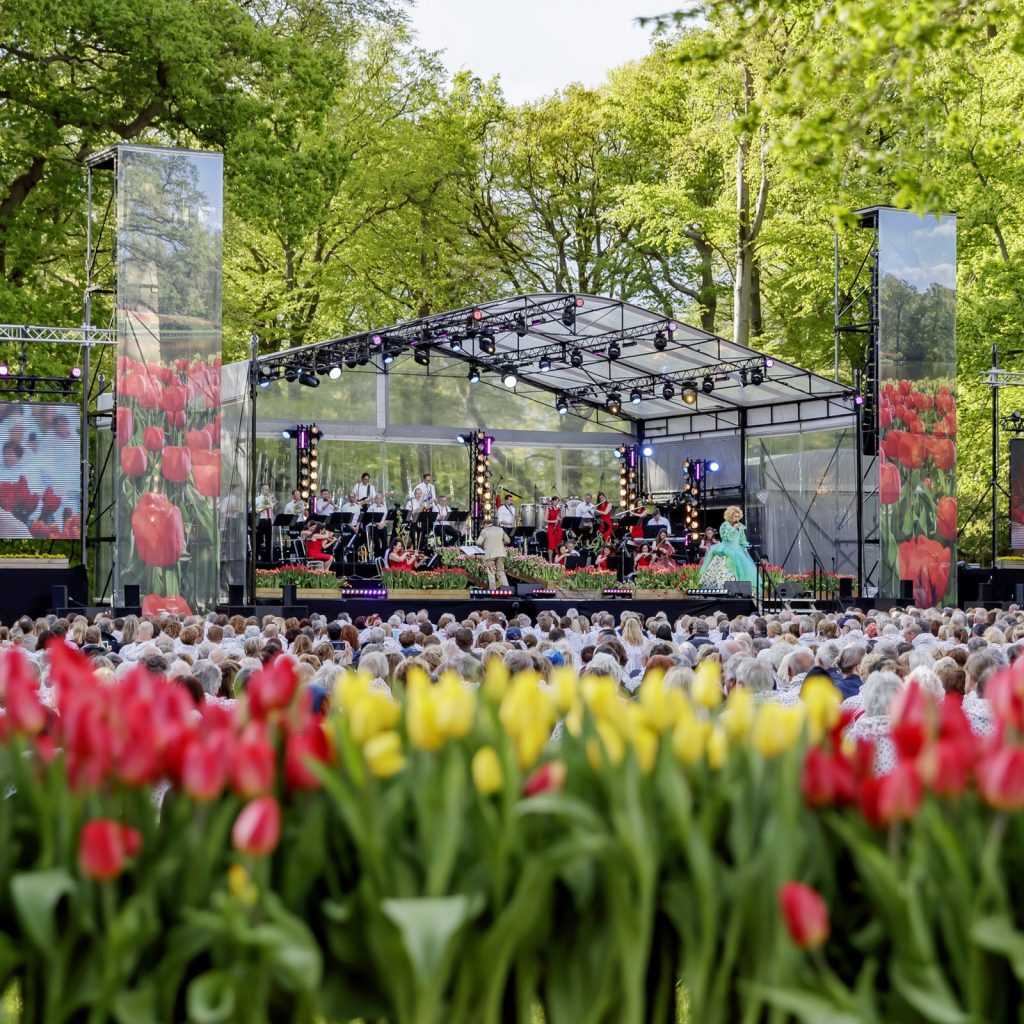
[116,354,221,606]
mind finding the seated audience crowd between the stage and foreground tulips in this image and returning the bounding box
[0,606,1007,772]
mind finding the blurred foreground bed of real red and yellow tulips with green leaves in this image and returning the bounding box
[0,643,1024,1024]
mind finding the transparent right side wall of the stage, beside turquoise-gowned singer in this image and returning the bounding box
[745,426,857,577]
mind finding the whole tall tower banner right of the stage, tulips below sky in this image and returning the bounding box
[879,210,956,606]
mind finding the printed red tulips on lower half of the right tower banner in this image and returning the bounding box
[879,380,957,606]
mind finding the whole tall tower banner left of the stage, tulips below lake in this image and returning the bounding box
[115,146,221,612]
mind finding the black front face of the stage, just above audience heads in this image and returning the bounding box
[243,591,757,623]
